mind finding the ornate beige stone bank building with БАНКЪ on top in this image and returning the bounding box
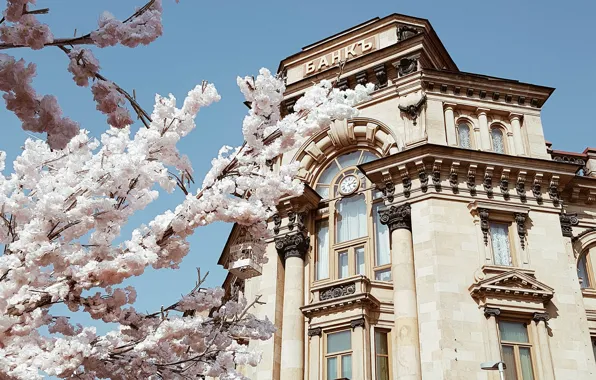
[219,14,596,380]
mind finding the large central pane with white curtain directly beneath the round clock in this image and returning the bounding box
[337,194,366,243]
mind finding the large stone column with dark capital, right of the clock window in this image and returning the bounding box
[379,203,422,380]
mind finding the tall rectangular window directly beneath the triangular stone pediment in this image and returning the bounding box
[499,321,534,380]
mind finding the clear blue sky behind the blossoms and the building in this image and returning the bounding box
[0,0,596,332]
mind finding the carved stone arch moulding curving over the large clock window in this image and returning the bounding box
[292,117,400,186]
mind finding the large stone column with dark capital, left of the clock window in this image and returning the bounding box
[275,232,309,380]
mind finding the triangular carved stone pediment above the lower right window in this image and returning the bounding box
[470,269,554,303]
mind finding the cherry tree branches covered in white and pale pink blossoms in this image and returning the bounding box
[0,0,372,380]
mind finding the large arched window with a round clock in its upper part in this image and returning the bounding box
[313,149,391,281]
